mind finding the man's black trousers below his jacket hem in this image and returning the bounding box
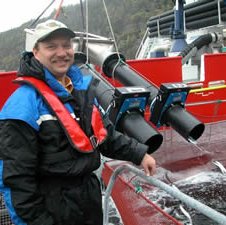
[40,174,103,225]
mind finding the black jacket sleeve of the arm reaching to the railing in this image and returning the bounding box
[100,119,148,165]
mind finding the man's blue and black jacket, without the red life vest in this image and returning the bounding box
[0,53,148,225]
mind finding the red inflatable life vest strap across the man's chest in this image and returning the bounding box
[15,76,107,153]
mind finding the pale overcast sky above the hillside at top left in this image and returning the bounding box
[0,0,79,32]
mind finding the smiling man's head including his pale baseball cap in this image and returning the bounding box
[33,21,75,80]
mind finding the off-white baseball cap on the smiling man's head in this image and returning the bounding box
[25,19,75,52]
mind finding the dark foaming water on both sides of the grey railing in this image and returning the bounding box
[145,172,226,225]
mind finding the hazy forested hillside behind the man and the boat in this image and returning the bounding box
[0,0,173,71]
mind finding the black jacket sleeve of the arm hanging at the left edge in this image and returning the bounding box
[0,120,53,225]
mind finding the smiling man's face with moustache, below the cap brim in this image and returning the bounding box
[33,36,74,79]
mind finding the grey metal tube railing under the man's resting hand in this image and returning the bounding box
[103,164,226,225]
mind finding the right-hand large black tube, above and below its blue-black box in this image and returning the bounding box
[103,56,204,140]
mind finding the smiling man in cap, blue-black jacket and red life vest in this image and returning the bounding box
[0,20,155,225]
